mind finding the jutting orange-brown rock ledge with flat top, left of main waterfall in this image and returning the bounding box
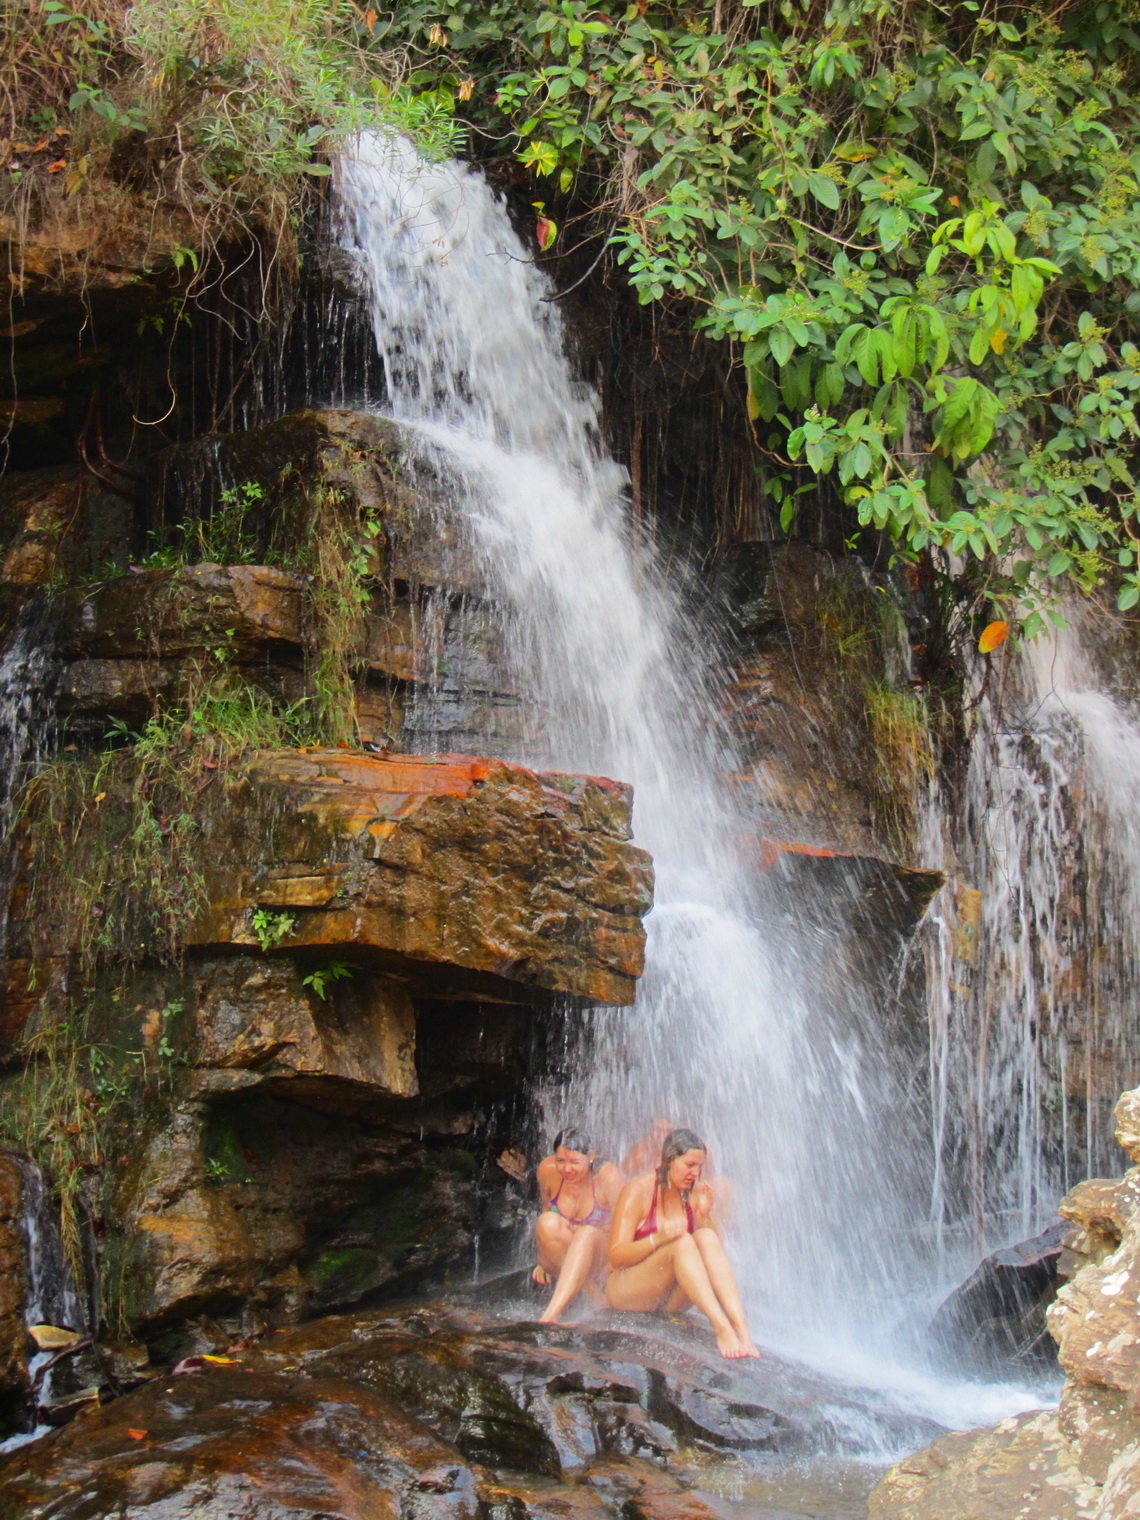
[9,749,652,1005]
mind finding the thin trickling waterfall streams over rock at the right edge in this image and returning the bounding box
[926,608,1140,1256]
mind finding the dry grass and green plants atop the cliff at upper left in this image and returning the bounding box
[0,0,461,234]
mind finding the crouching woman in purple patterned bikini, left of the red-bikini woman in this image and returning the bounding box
[534,1128,623,1325]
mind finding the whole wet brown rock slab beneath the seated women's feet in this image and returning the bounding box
[0,1304,948,1520]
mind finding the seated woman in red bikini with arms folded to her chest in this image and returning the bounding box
[605,1129,760,1359]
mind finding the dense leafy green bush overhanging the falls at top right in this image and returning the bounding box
[398,0,1140,623]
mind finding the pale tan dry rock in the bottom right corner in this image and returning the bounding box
[868,1088,1140,1520]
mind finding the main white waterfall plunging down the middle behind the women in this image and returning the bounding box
[337,135,1051,1422]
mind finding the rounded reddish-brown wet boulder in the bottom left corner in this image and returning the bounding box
[0,1366,480,1520]
